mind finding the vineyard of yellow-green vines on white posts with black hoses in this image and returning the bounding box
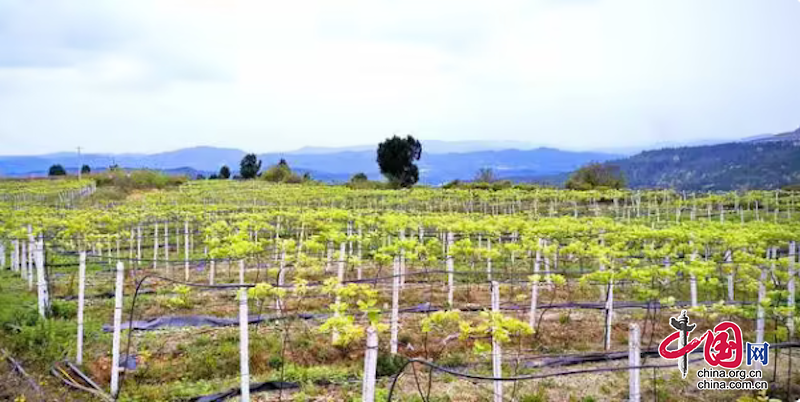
[0,180,800,402]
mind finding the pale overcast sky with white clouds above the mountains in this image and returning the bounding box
[0,0,800,155]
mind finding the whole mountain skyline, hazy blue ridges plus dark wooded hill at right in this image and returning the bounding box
[0,129,800,190]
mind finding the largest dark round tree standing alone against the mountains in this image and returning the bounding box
[377,135,422,187]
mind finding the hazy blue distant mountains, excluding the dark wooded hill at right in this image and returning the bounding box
[0,141,621,184]
